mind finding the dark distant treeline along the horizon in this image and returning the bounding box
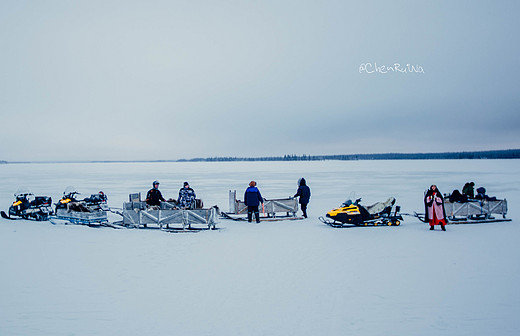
[178,149,520,162]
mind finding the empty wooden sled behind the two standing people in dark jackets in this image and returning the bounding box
[221,190,303,221]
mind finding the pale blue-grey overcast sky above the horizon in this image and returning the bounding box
[0,0,520,161]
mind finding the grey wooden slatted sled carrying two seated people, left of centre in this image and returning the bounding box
[121,193,219,231]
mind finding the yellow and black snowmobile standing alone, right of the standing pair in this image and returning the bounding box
[319,197,403,227]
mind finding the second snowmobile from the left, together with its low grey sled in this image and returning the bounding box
[51,187,110,226]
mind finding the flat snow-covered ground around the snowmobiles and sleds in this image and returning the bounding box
[0,160,520,336]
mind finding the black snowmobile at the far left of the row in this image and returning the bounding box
[1,191,54,221]
